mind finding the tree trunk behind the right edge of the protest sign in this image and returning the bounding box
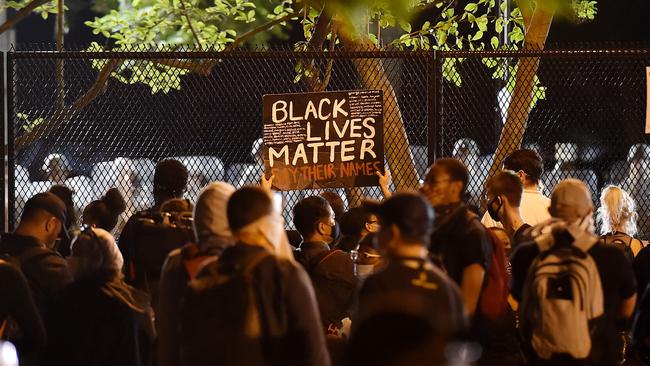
[340,32,418,199]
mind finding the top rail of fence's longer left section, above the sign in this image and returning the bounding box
[9,50,434,60]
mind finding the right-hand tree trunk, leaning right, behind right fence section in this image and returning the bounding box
[488,1,555,178]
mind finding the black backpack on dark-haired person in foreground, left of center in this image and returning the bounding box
[180,250,271,366]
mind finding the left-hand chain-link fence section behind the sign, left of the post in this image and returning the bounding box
[3,47,434,233]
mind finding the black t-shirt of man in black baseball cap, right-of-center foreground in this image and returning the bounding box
[353,258,467,337]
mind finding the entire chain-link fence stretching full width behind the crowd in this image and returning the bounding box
[7,46,650,238]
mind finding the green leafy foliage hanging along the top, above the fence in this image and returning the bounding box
[5,0,597,102]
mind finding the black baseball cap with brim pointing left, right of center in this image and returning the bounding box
[364,193,434,243]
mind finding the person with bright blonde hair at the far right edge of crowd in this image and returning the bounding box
[597,185,643,259]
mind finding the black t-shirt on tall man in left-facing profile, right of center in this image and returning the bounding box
[430,204,492,286]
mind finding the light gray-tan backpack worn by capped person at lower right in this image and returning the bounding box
[521,233,604,359]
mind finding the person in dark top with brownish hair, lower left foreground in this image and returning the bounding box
[42,226,153,366]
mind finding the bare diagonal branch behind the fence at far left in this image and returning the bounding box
[15,59,124,150]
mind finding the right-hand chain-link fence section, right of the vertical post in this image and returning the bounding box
[435,49,650,239]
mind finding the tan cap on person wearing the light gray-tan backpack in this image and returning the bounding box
[551,178,594,221]
